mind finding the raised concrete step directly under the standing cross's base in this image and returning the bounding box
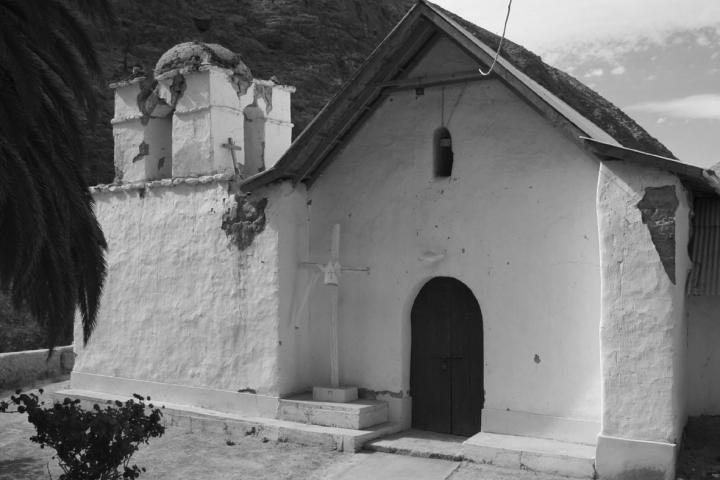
[278,393,388,430]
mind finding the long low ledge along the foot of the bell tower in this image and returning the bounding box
[48,389,402,452]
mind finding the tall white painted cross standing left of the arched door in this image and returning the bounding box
[301,223,370,388]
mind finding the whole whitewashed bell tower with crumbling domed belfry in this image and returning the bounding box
[72,42,306,416]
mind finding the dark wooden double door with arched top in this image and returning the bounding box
[410,277,485,436]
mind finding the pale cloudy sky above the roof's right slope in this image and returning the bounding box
[435,0,720,167]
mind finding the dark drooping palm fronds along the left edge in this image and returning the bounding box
[0,0,114,348]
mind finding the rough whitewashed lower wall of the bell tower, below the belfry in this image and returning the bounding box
[72,182,293,416]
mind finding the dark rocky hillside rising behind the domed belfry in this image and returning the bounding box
[86,0,413,185]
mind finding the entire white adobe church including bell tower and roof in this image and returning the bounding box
[66,1,720,479]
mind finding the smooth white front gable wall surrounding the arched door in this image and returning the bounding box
[302,77,601,443]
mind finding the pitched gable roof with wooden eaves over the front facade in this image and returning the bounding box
[241,0,673,191]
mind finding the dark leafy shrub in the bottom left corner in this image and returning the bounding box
[0,389,165,480]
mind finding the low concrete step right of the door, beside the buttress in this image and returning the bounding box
[462,432,595,478]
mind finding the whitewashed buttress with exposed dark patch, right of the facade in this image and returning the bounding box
[596,162,691,479]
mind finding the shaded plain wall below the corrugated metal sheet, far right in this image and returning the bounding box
[687,296,720,415]
